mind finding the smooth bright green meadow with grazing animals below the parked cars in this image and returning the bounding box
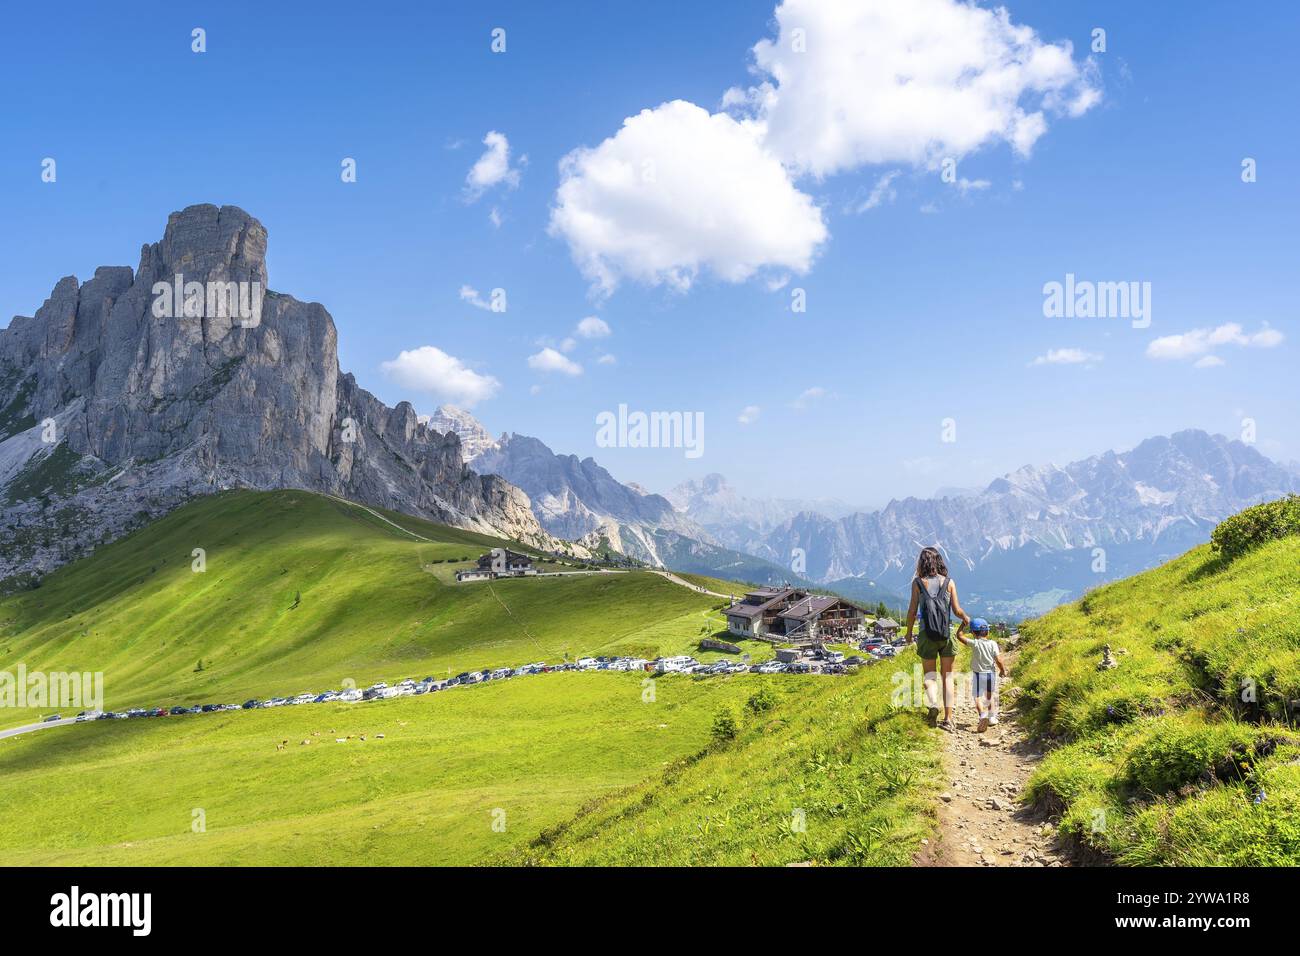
[0,674,764,865]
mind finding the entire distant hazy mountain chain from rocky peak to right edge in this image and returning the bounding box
[405,410,1300,618]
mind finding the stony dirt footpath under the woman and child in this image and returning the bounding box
[917,654,1070,866]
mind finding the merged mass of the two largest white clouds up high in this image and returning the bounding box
[549,0,1101,295]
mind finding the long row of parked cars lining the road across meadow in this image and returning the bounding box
[43,648,892,723]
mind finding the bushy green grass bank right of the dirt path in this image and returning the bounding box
[1018,537,1300,865]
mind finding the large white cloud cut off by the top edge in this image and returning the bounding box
[724,0,1101,178]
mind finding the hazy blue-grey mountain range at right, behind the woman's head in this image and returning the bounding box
[738,431,1300,617]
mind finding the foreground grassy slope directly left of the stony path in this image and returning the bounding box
[495,654,941,866]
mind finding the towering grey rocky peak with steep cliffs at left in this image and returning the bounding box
[0,204,558,579]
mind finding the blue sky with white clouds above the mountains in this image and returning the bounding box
[0,0,1300,505]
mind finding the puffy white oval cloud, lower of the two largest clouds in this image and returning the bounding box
[550,100,827,294]
